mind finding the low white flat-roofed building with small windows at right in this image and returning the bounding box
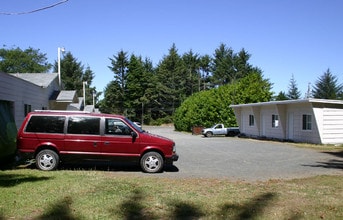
[230,99,343,144]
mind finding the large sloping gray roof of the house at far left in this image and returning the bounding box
[11,73,58,88]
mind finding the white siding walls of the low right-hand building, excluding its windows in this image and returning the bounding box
[234,101,330,144]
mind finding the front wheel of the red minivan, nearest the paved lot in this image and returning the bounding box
[140,151,164,173]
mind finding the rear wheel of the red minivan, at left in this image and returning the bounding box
[36,150,59,171]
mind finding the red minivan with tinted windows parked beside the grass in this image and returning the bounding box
[17,111,179,173]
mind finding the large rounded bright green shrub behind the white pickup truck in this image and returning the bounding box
[174,73,272,131]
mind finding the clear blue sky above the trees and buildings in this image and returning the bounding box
[0,0,343,96]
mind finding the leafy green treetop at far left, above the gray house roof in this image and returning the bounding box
[0,47,52,73]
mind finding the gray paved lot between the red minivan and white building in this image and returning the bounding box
[145,126,343,181]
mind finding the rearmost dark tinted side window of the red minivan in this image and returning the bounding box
[25,115,66,134]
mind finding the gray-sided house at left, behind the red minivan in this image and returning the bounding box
[0,72,83,128]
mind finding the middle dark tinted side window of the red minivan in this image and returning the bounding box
[67,116,100,135]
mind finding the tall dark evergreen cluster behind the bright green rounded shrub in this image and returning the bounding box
[99,44,271,124]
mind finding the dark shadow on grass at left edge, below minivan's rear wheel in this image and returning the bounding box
[0,173,51,187]
